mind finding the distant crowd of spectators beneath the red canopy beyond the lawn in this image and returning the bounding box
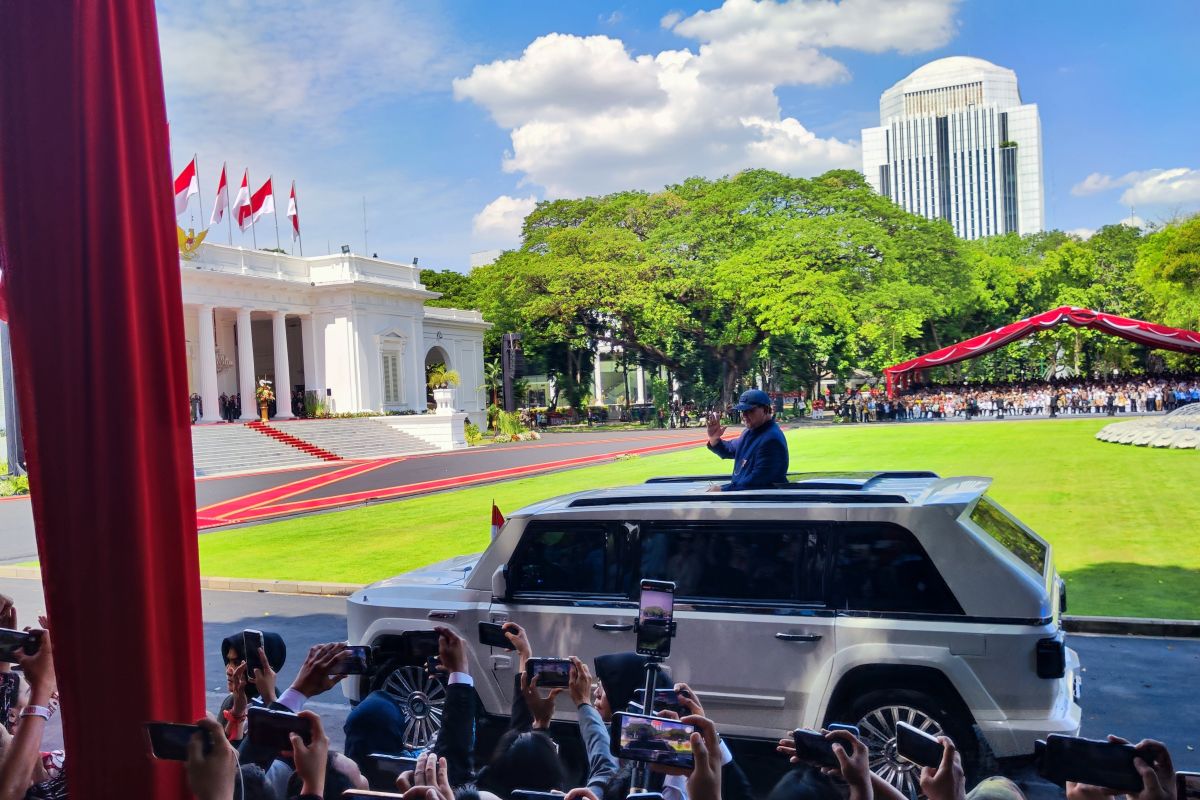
[814,374,1200,422]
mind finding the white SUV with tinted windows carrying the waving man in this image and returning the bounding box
[343,473,1080,789]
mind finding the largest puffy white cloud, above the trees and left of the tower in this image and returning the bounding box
[454,0,958,198]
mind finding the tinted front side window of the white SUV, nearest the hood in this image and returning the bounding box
[509,521,624,595]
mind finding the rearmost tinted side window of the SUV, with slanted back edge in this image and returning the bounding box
[829,523,962,614]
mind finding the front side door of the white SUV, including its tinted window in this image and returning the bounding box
[490,518,637,720]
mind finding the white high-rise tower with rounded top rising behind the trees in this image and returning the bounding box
[863,55,1045,239]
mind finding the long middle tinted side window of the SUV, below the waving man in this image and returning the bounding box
[640,522,822,603]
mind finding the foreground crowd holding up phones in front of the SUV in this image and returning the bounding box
[84,622,1182,800]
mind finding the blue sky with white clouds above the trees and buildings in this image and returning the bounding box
[158,0,1200,271]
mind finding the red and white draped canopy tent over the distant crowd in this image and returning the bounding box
[883,306,1200,397]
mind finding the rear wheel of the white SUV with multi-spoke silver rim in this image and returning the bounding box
[842,690,977,798]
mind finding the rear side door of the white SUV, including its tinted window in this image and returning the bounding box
[638,521,836,736]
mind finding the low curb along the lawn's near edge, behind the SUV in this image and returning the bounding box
[0,566,1200,623]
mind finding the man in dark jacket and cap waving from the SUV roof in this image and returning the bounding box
[708,389,787,492]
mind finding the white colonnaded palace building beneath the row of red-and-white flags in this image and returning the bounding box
[180,242,490,422]
